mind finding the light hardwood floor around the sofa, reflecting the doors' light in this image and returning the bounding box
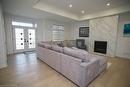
[0,53,130,87]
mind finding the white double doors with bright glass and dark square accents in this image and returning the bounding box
[13,27,35,53]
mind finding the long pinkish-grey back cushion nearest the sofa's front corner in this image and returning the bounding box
[63,47,88,61]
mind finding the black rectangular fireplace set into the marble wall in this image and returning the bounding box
[94,41,107,54]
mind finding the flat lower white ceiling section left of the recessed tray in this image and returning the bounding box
[2,0,75,22]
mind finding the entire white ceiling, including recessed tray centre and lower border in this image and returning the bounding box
[3,0,130,22]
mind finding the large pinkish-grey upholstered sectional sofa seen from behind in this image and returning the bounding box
[37,43,107,87]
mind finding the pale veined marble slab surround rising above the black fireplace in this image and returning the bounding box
[89,15,118,57]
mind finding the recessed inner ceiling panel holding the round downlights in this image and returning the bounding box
[39,0,130,16]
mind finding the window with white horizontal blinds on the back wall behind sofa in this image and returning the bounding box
[52,25,64,41]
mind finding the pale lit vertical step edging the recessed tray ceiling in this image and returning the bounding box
[33,2,130,21]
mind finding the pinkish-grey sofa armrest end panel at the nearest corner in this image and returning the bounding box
[80,59,99,87]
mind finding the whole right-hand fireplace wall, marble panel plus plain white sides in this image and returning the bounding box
[71,12,130,59]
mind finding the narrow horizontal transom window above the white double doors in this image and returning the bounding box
[12,21,37,28]
